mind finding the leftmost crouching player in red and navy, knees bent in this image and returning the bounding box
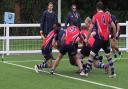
[35,23,61,73]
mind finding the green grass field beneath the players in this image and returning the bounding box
[0,52,128,89]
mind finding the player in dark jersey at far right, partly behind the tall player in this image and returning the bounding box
[106,10,121,58]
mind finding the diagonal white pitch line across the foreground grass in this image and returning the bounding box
[3,61,123,89]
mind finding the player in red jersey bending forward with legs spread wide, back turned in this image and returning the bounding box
[51,19,85,76]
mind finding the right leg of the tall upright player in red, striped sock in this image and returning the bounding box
[103,40,116,77]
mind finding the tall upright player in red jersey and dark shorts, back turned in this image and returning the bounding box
[85,1,116,77]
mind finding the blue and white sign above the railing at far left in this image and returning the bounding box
[4,12,15,24]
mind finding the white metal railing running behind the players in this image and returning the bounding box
[0,21,128,55]
